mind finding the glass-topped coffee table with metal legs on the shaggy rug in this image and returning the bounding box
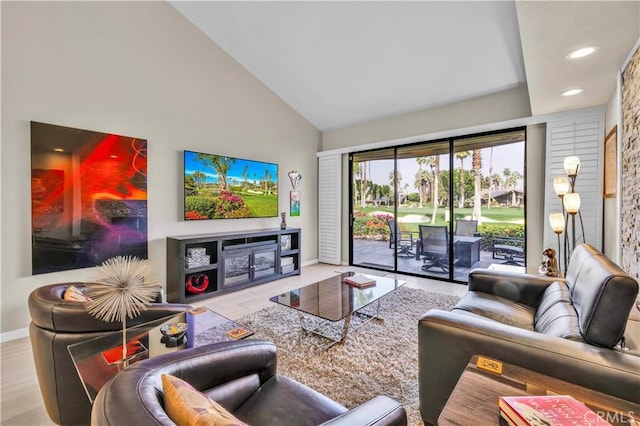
[269,272,405,349]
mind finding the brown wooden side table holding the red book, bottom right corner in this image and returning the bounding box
[438,355,640,426]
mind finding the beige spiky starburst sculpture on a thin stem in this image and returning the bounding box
[85,256,160,365]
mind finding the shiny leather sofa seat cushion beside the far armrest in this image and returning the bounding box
[453,291,535,330]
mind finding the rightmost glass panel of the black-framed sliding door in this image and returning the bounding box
[451,129,525,281]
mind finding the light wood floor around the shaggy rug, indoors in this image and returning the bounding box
[0,264,467,426]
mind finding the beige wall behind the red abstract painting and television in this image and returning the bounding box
[0,2,320,336]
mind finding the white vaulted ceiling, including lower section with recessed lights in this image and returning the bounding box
[170,1,640,131]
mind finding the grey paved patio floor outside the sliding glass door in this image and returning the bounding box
[353,239,524,282]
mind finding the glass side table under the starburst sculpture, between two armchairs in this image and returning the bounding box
[67,307,253,403]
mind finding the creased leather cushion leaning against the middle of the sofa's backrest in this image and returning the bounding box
[534,281,582,341]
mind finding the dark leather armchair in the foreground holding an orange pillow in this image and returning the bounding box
[91,339,407,426]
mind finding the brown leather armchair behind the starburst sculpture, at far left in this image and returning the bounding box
[28,283,189,425]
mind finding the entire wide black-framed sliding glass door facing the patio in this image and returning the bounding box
[350,129,525,282]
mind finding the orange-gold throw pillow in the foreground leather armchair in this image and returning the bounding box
[162,374,247,426]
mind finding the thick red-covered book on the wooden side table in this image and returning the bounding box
[498,395,610,426]
